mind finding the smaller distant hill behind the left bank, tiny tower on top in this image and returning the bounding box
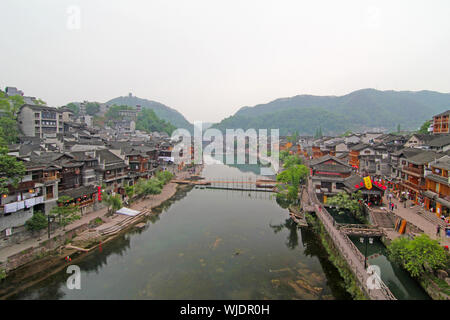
[106,96,193,132]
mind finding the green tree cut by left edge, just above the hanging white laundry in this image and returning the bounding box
[0,147,26,194]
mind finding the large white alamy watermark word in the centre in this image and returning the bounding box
[172,122,279,175]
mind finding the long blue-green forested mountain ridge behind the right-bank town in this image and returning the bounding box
[214,89,450,135]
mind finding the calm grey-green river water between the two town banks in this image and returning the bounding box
[2,164,426,299]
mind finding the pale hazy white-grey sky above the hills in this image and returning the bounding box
[0,0,450,121]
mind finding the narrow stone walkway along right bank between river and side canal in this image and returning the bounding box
[308,180,397,300]
